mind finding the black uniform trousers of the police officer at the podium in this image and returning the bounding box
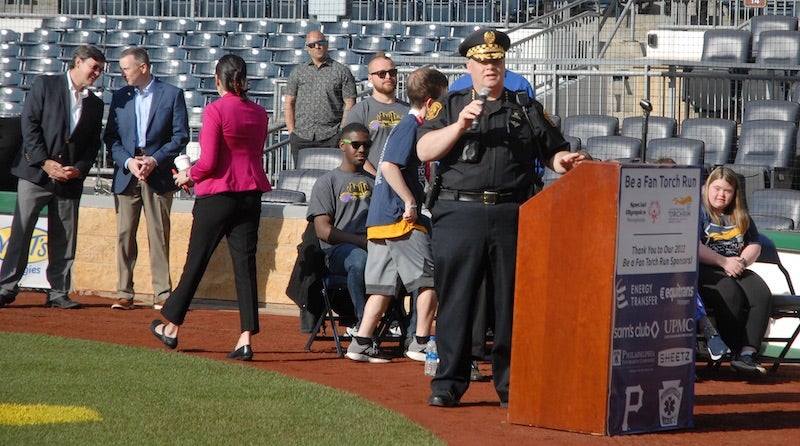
[431,200,519,402]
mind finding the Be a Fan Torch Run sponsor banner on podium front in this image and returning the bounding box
[608,166,701,435]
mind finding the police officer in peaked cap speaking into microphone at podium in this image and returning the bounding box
[417,29,583,407]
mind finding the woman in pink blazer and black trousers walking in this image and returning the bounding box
[150,54,271,361]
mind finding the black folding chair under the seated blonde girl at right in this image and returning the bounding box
[756,234,800,372]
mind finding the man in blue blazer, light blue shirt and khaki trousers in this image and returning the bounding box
[104,47,189,310]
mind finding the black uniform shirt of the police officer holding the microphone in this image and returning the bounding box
[418,89,569,193]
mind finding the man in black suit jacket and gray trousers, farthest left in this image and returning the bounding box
[0,45,106,308]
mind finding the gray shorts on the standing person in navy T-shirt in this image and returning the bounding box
[364,229,433,296]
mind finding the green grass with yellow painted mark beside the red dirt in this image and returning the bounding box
[0,333,444,445]
